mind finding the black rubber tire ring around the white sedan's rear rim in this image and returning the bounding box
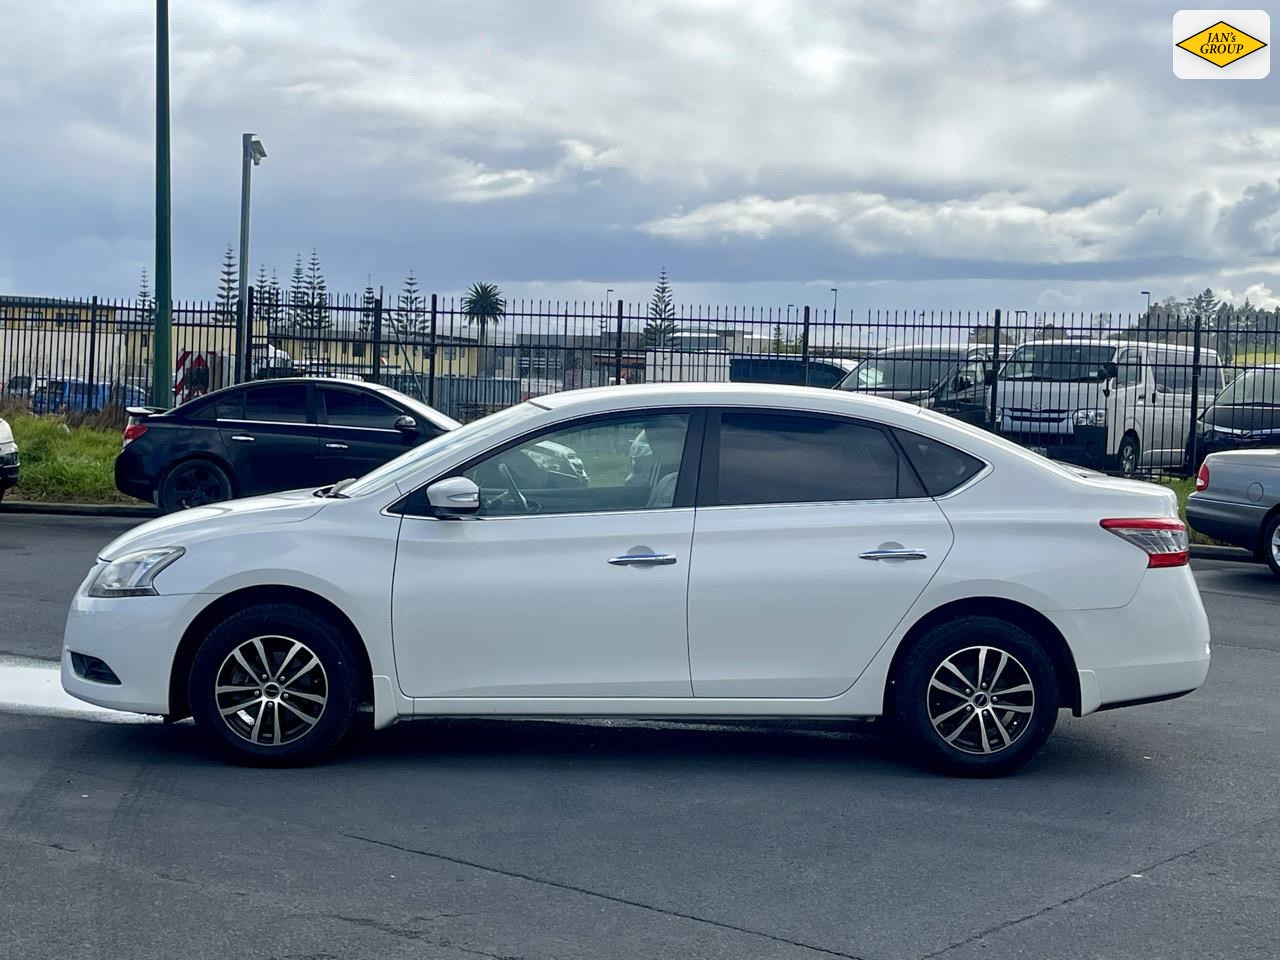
[893,616,1061,777]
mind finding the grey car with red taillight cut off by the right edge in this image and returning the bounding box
[1187,449,1280,576]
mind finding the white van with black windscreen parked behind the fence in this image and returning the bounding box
[996,339,1224,475]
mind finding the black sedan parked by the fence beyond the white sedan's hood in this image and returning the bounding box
[115,378,458,512]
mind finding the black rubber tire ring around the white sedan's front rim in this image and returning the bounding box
[187,603,360,767]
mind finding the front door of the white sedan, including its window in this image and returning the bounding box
[392,411,700,698]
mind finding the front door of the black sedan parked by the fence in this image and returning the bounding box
[315,384,427,484]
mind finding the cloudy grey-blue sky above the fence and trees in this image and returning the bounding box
[0,0,1280,314]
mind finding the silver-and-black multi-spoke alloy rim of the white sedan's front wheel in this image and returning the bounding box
[214,636,329,746]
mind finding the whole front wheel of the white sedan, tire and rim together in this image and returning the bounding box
[187,603,360,767]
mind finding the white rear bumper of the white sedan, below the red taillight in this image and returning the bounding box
[1046,567,1210,714]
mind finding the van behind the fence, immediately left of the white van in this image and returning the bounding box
[836,343,991,424]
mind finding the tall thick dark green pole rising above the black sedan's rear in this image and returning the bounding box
[151,0,173,407]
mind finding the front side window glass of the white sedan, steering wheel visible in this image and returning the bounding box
[463,413,689,517]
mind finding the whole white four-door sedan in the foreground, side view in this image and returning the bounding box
[61,384,1210,774]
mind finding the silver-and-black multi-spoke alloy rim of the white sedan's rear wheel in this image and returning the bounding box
[925,646,1036,755]
